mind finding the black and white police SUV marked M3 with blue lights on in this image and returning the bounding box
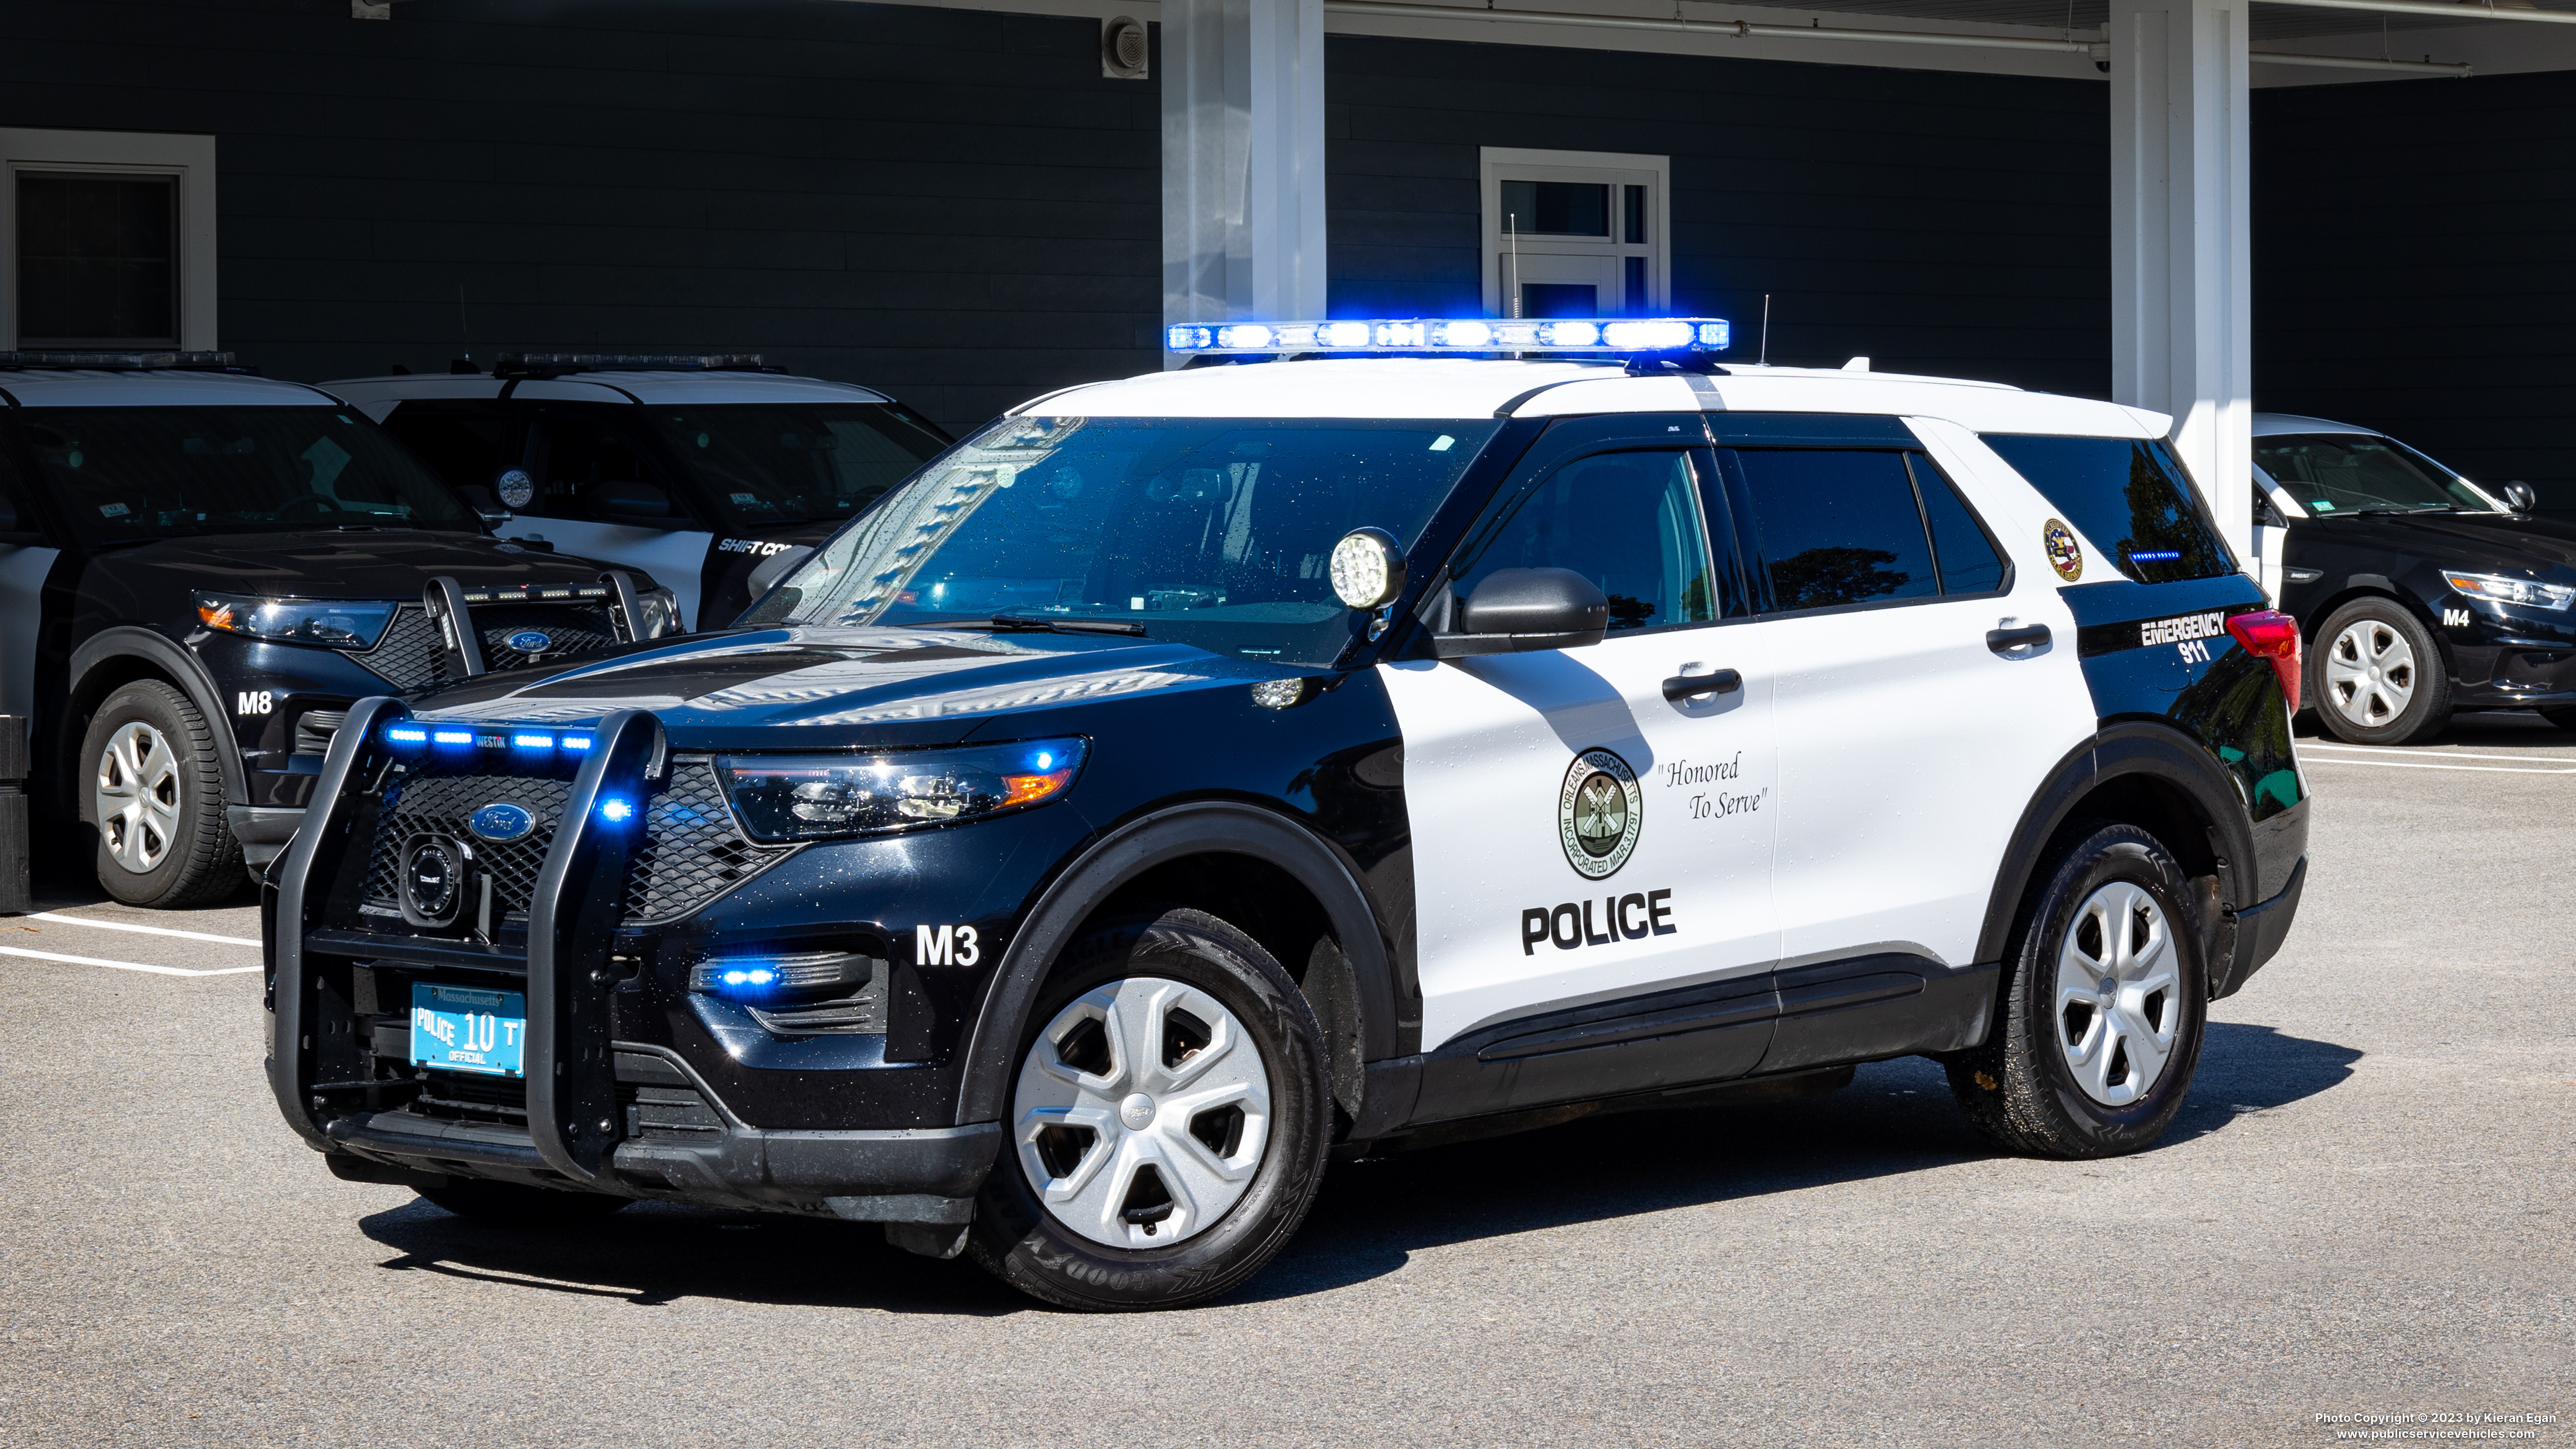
[268,319,2308,1309]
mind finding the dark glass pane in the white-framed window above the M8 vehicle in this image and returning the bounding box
[18,170,178,345]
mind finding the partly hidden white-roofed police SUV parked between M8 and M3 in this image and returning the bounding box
[325,353,951,629]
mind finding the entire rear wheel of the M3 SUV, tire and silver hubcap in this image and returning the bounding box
[1948,825,2208,1158]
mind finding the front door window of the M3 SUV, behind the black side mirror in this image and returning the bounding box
[1455,451,1718,632]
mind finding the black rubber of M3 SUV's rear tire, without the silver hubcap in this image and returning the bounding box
[1945,825,2210,1158]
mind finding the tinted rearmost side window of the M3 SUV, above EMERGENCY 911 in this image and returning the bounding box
[1983,433,2236,583]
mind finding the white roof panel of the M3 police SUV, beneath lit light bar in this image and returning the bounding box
[1015,356,2169,438]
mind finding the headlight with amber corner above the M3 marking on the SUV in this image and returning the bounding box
[716,737,1087,841]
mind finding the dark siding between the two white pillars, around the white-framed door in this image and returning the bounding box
[1324,36,2110,397]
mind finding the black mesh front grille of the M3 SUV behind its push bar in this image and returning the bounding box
[366,761,796,926]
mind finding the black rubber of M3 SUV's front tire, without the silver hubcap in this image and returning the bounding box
[966,907,1332,1312]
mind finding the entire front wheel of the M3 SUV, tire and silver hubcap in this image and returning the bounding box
[966,910,1332,1309]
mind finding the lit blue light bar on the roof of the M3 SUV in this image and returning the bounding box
[1162,317,1734,356]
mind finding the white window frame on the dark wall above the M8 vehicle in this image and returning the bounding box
[0,127,214,351]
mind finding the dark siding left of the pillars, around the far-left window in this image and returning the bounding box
[0,0,1162,426]
